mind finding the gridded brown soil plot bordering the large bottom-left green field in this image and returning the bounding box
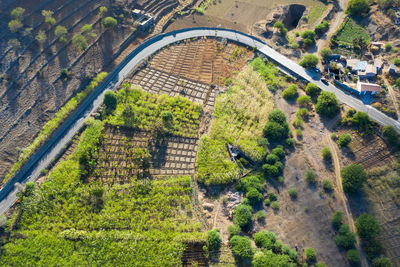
[93,126,198,184]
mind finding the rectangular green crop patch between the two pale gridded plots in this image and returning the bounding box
[104,87,202,137]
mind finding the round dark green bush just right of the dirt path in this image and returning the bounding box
[340,164,367,193]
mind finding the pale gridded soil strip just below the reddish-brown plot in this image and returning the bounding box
[130,68,216,108]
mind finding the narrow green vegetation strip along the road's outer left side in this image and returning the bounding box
[3,72,107,183]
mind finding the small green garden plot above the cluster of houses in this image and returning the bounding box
[334,18,371,45]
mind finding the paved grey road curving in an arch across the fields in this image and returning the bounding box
[0,28,400,214]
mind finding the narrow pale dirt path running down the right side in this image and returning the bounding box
[325,118,369,266]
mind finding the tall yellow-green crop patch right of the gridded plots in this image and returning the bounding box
[197,63,278,185]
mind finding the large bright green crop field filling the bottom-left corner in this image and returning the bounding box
[0,120,205,266]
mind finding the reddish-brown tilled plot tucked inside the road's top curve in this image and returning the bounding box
[150,38,253,85]
